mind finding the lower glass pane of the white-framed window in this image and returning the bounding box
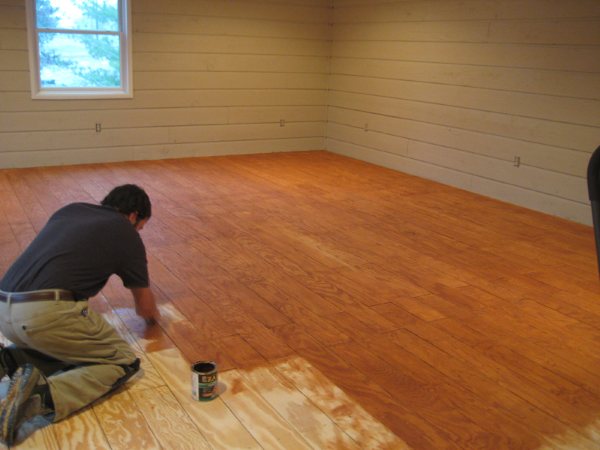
[39,33,121,88]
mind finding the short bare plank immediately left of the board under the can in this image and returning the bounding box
[131,386,210,450]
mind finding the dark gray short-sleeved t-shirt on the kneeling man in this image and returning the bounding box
[0,203,149,300]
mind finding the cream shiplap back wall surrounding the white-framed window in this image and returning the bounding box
[0,0,332,167]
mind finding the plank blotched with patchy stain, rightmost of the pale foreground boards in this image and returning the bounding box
[275,358,410,449]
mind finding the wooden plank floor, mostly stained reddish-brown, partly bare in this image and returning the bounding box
[0,152,600,449]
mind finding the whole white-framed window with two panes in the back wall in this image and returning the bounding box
[27,0,132,98]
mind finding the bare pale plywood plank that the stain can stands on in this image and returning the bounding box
[148,349,261,450]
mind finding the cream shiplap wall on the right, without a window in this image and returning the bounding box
[327,0,600,224]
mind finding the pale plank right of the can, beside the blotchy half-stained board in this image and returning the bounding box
[240,367,363,450]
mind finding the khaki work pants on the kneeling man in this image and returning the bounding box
[0,294,136,422]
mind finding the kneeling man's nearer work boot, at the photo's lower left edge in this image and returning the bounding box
[0,364,53,446]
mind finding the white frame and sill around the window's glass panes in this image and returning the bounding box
[26,0,133,100]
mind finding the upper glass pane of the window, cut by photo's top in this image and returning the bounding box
[35,0,119,31]
